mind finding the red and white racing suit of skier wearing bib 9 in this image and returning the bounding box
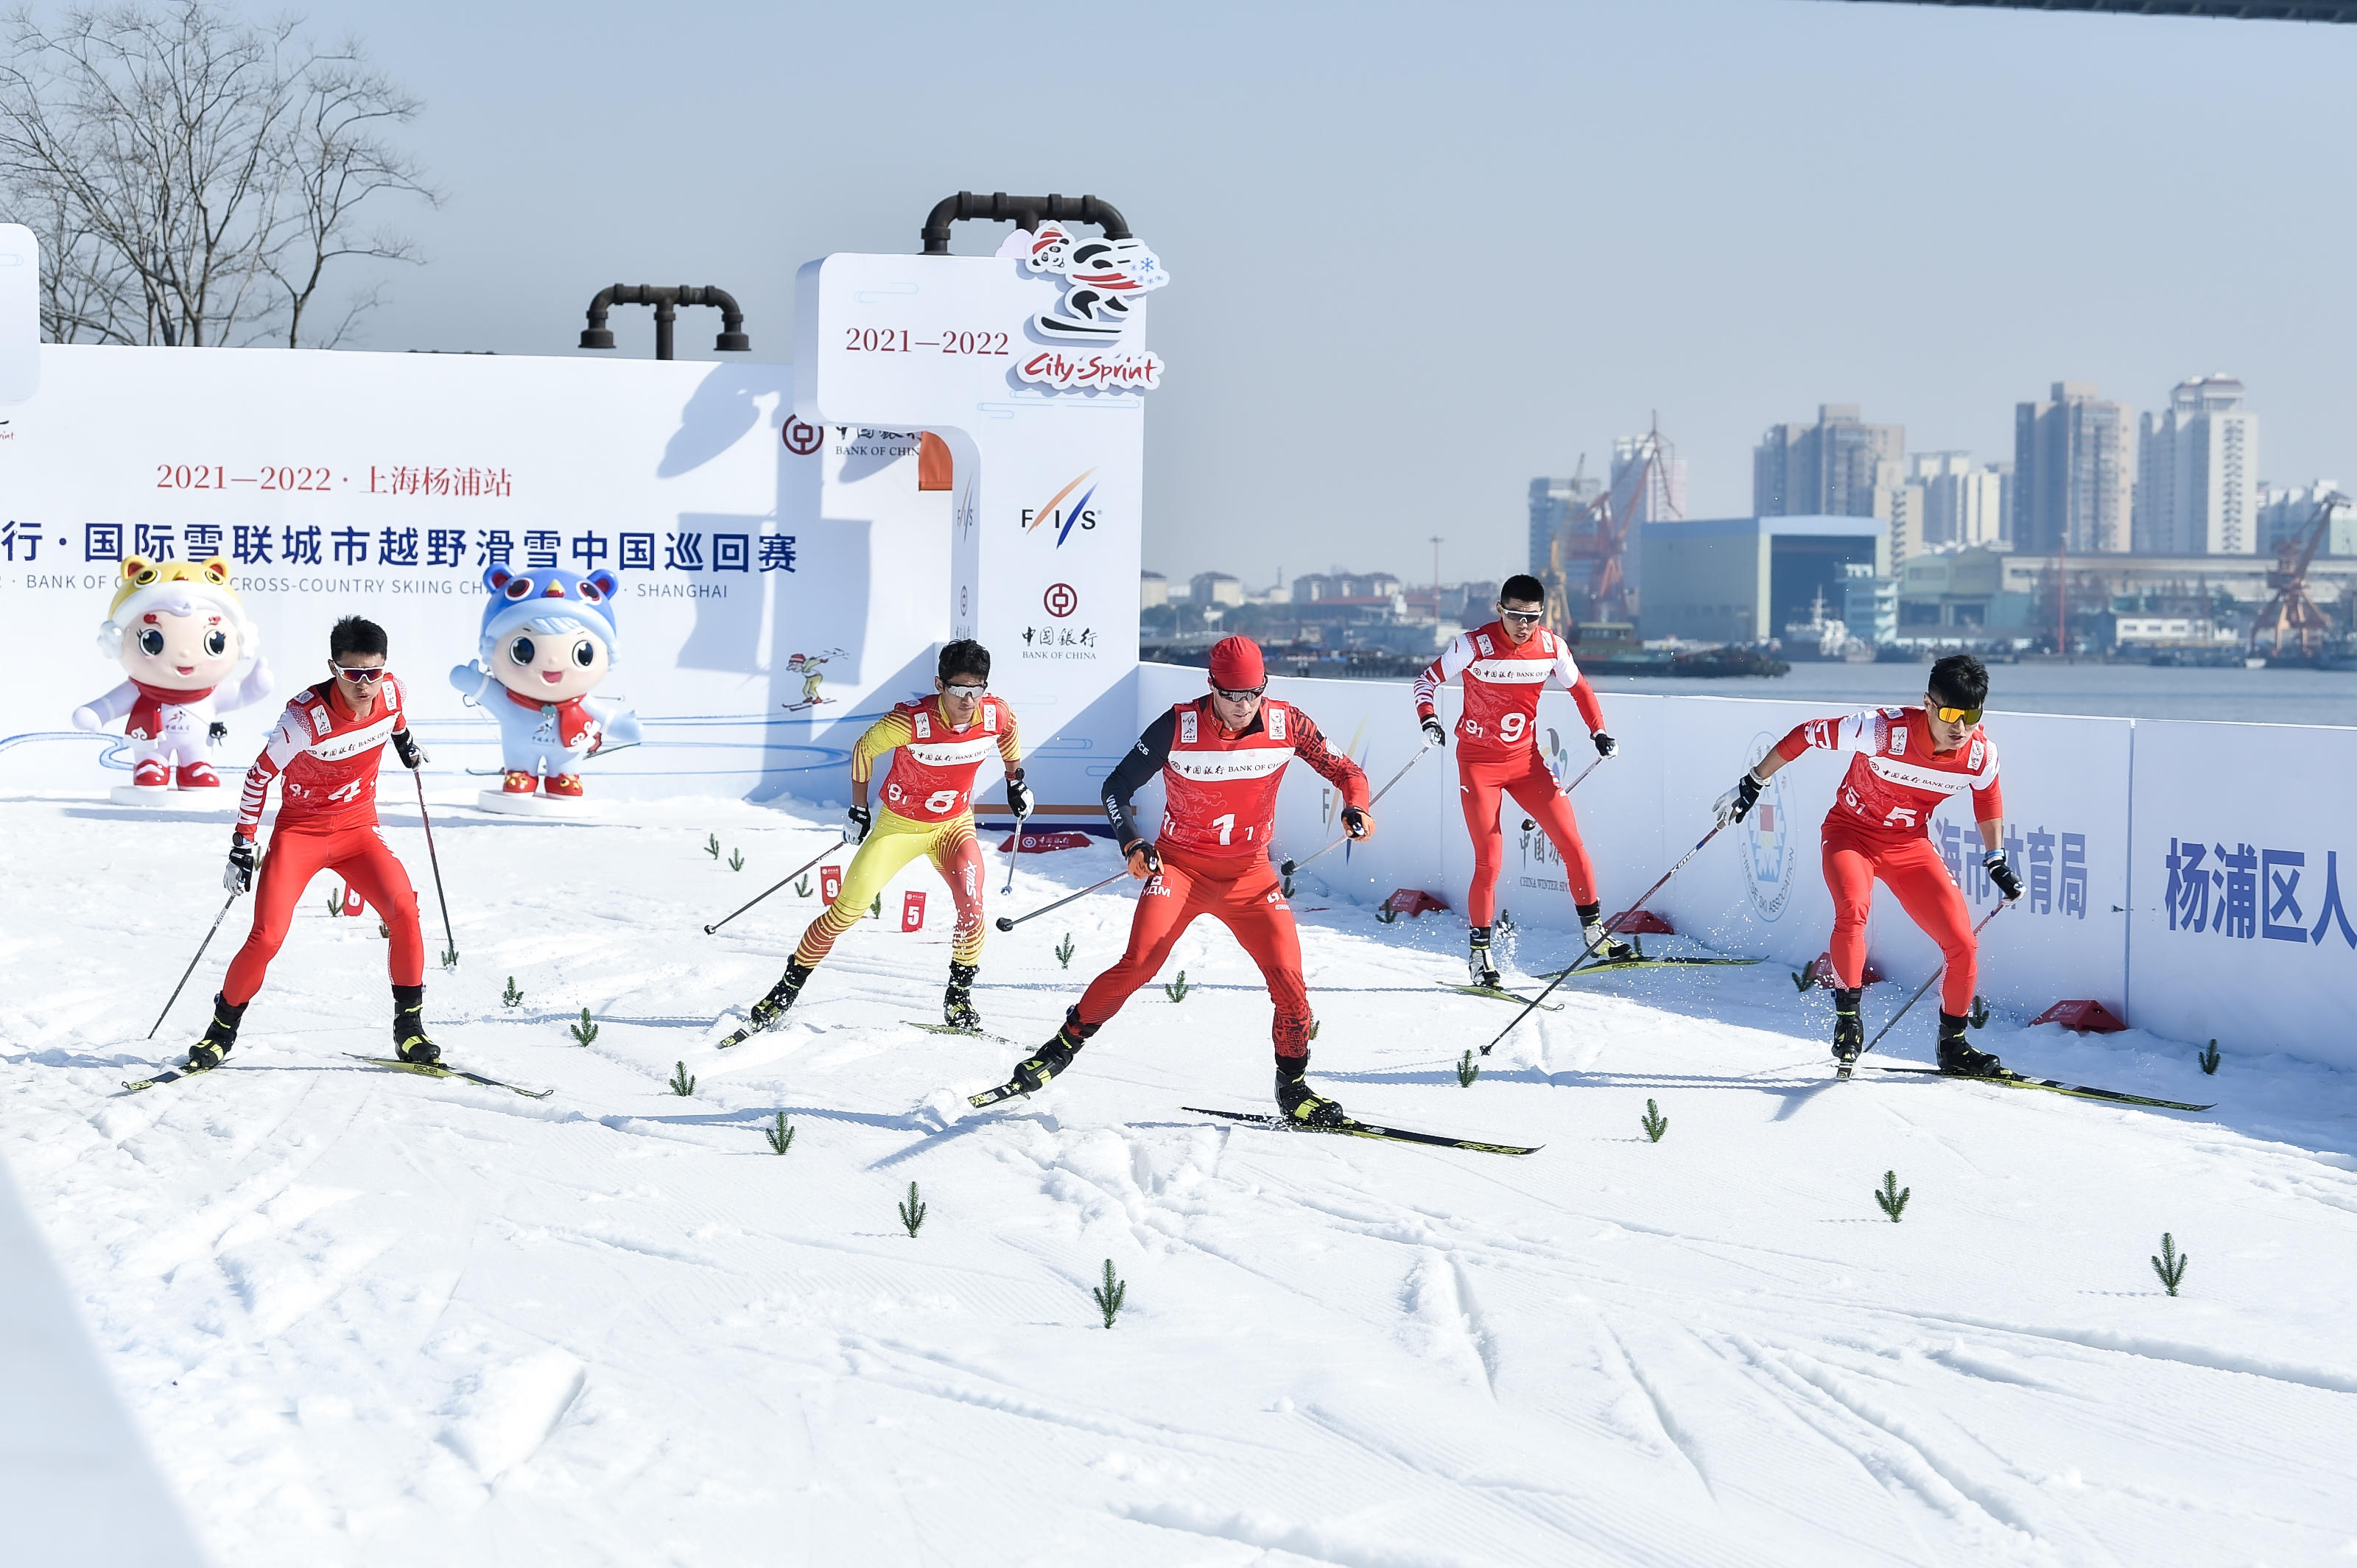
[1416,620,1605,927]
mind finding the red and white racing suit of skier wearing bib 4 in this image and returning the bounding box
[222,677,426,1007]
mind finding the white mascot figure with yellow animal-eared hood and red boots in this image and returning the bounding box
[73,557,275,804]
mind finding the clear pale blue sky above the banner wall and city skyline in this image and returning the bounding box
[285,0,2357,583]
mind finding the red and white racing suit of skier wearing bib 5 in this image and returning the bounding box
[1775,707,2006,1016]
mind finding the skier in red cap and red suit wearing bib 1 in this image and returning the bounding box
[1014,636,1374,1127]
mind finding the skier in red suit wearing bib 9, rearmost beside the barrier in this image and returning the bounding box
[1416,575,1629,991]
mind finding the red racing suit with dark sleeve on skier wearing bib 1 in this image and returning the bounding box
[1072,695,1367,1064]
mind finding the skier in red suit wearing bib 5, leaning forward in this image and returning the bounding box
[1718,653,2023,1077]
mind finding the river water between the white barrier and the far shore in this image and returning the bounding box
[1591,660,2357,726]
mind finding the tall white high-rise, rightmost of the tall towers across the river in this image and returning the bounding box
[2133,375,2265,557]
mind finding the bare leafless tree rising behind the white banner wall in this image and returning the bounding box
[0,0,440,347]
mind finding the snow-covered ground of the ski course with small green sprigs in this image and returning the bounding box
[0,795,2357,1568]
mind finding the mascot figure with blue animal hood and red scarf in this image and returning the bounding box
[450,566,639,804]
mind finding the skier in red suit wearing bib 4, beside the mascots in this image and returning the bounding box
[189,616,440,1073]
